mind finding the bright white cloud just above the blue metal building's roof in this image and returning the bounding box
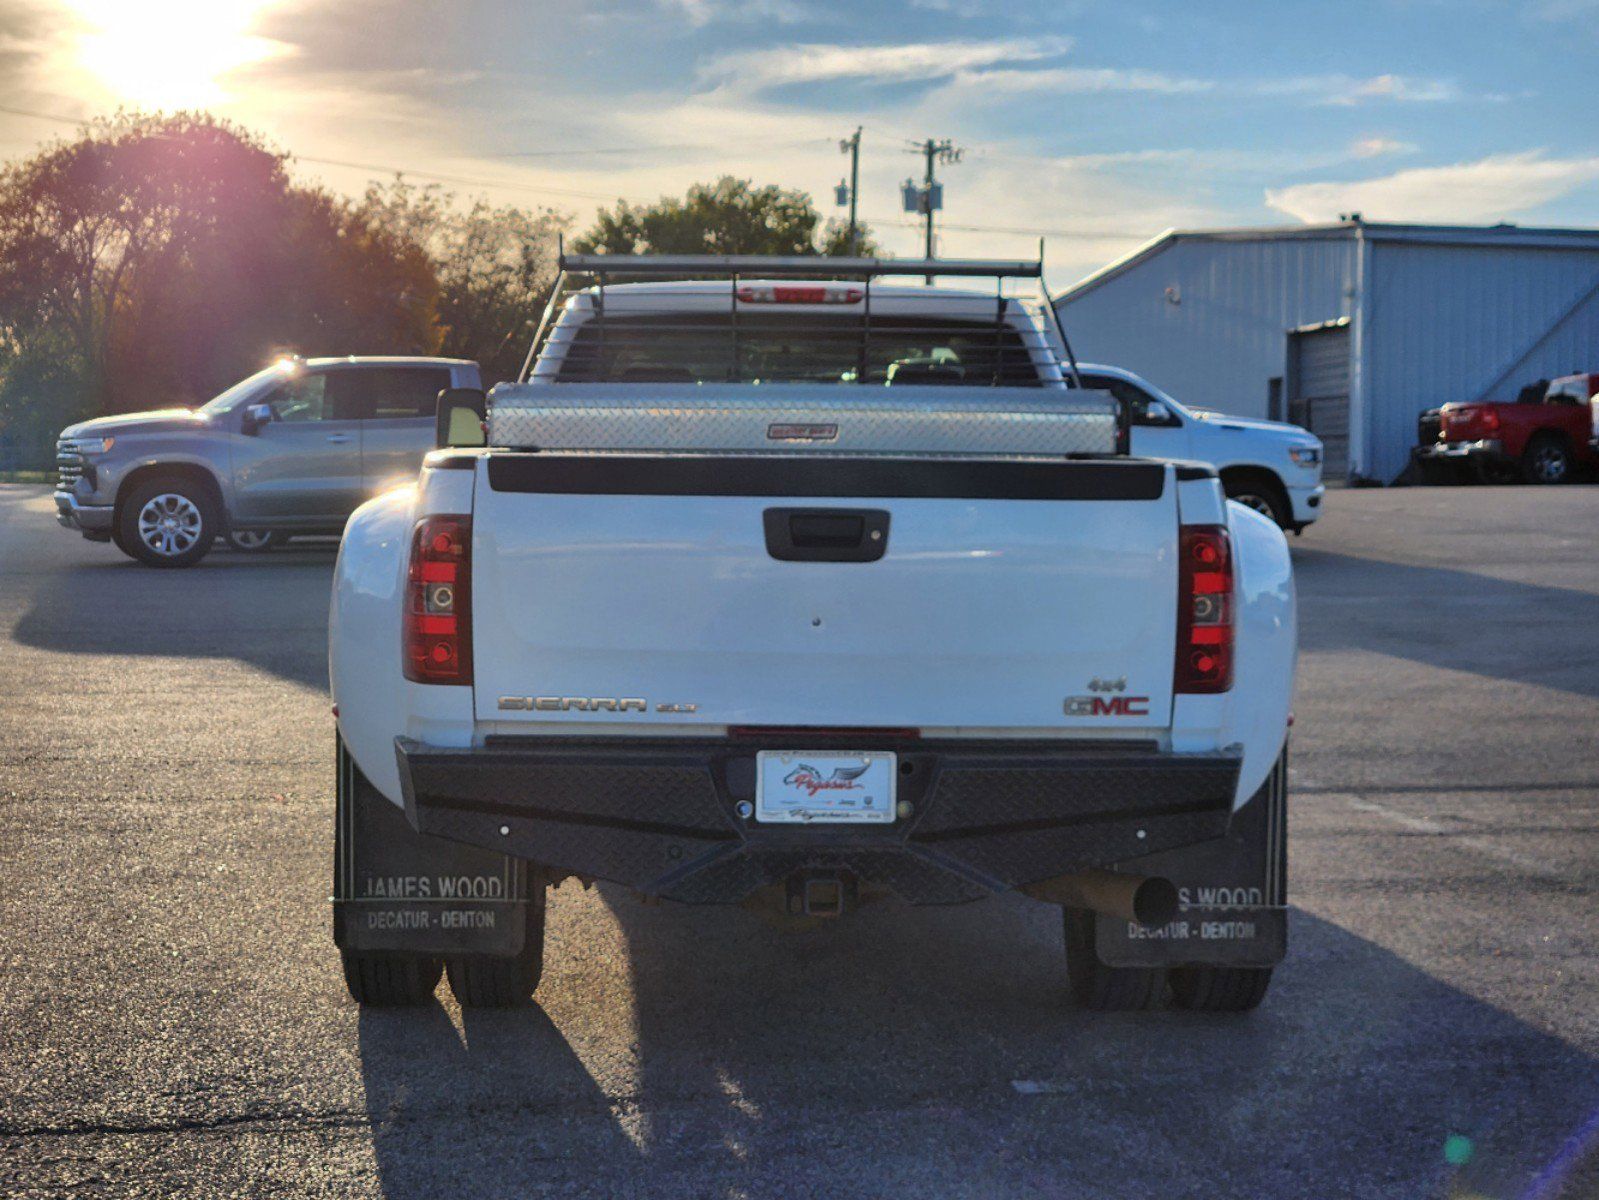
[1266,150,1599,224]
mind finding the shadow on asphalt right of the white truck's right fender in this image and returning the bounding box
[1294,547,1599,696]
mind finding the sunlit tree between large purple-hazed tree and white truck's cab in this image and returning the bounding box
[360,179,569,382]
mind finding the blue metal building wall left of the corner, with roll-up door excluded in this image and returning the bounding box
[1060,234,1354,416]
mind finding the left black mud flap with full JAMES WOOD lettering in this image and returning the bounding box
[333,739,528,955]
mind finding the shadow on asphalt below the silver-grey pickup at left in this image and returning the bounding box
[11,547,333,691]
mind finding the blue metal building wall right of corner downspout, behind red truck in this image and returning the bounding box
[1366,240,1599,480]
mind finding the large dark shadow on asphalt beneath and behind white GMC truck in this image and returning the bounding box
[350,888,1599,1200]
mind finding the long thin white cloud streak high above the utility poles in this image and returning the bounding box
[699,37,1071,91]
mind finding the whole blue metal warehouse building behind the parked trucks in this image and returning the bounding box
[1055,218,1599,483]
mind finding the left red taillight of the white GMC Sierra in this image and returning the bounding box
[401,517,472,683]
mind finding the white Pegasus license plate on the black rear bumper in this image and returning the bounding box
[755,750,895,824]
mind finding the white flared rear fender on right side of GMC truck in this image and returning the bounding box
[1226,501,1298,806]
